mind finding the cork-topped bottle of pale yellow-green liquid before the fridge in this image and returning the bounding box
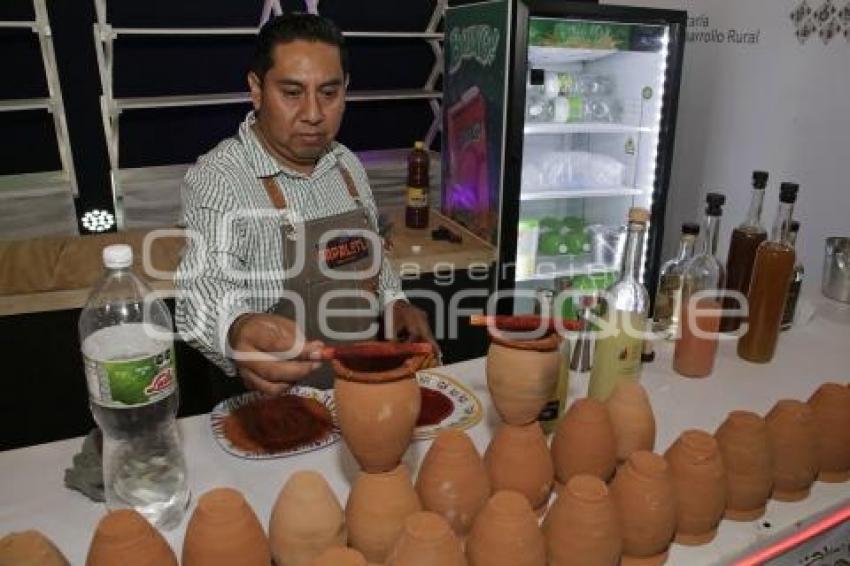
[588,208,649,401]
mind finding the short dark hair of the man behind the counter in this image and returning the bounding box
[251,12,348,80]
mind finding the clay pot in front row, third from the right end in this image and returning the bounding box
[714,411,773,521]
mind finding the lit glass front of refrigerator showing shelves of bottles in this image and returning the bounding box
[514,15,669,318]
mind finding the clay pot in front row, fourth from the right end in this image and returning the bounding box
[664,430,726,545]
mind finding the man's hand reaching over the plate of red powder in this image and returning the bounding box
[227,313,324,395]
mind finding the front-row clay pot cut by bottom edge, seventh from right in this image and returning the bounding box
[466,491,546,566]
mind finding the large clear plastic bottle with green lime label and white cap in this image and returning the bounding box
[79,244,189,529]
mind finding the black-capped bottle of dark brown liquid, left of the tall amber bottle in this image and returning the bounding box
[720,171,767,332]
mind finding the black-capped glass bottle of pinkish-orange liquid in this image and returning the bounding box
[673,193,726,377]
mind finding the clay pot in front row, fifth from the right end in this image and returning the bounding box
[611,450,676,564]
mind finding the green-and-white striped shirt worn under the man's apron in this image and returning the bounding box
[175,112,404,375]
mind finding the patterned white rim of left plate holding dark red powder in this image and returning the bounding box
[210,385,340,460]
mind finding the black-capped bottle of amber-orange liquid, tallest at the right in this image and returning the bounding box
[738,183,799,364]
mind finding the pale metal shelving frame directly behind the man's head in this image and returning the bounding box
[94,0,447,229]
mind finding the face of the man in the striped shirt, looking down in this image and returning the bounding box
[248,40,346,174]
